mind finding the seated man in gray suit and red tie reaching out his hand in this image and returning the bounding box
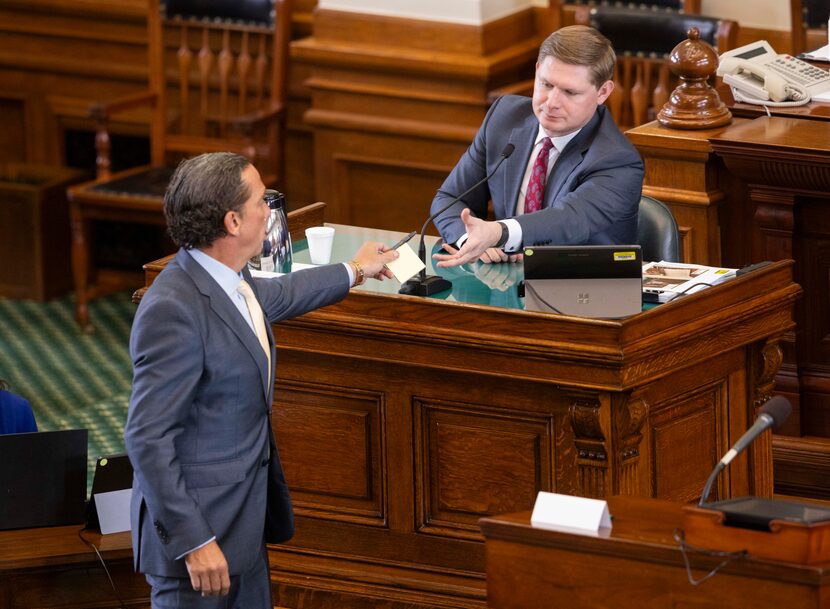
[431,25,643,266]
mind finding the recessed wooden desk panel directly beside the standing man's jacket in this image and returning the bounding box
[272,383,386,526]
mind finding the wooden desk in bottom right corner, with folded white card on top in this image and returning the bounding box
[481,497,830,609]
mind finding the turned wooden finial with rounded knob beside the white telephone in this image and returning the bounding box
[657,28,732,129]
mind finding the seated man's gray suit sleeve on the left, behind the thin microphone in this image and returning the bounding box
[430,98,510,243]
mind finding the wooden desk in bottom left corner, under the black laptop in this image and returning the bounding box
[0,525,150,609]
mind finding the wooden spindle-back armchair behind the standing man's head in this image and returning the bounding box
[68,0,292,328]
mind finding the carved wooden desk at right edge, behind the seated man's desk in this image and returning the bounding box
[628,114,830,498]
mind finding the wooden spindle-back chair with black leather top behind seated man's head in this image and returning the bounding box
[577,6,738,129]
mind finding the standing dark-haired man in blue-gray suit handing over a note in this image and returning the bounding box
[124,153,398,609]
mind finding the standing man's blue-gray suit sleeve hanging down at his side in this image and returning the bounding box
[124,294,214,560]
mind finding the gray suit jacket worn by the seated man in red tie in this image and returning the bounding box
[431,95,643,246]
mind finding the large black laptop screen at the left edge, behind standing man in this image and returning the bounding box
[0,429,88,529]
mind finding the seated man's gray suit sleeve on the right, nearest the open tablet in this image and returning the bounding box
[516,138,644,246]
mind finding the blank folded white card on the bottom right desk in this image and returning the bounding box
[530,491,611,533]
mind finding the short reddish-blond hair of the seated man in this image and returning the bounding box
[537,25,617,88]
